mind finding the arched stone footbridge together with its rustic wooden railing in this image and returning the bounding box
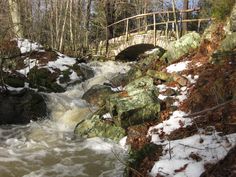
[97,8,211,60]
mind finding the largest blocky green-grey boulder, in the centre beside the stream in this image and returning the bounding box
[106,76,160,128]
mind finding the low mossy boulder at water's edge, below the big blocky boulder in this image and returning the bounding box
[74,115,125,141]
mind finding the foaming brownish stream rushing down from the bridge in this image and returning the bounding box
[0,61,129,177]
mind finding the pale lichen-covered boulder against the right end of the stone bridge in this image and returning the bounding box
[161,32,201,63]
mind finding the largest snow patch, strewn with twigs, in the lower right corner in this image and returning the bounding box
[150,132,236,177]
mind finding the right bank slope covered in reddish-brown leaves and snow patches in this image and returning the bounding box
[128,23,236,177]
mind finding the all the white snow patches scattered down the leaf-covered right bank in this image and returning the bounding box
[147,58,236,177]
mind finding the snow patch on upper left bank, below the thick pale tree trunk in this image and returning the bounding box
[16,38,44,54]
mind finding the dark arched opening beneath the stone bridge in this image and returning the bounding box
[115,44,162,61]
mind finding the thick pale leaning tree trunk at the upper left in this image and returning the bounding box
[8,0,23,38]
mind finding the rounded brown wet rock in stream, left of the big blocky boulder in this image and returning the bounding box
[82,85,115,106]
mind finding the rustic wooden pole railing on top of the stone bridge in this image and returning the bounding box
[106,8,213,52]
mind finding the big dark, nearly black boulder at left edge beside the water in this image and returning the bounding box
[0,89,47,124]
